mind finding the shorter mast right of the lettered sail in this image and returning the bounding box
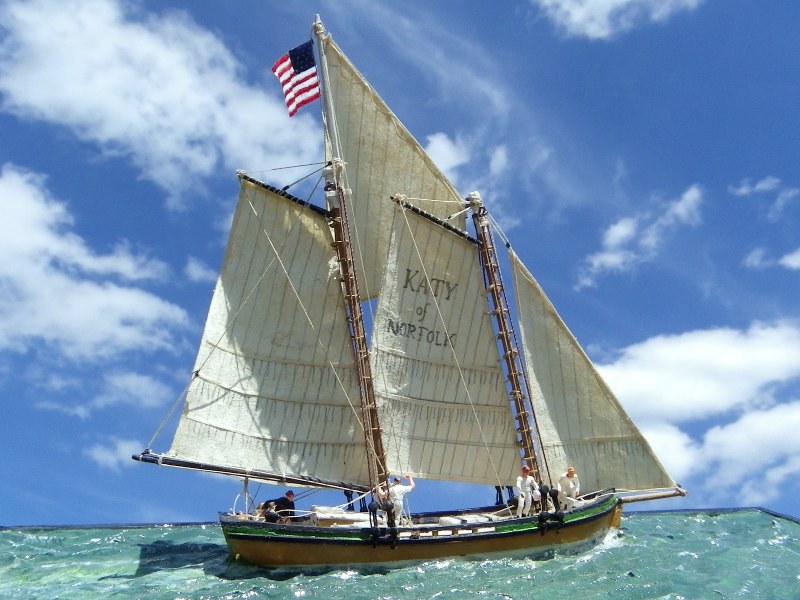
[467,192,542,481]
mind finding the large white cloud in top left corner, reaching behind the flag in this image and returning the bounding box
[0,0,321,204]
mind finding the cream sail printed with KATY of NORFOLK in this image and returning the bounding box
[372,207,520,485]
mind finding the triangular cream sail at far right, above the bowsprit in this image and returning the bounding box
[510,252,675,492]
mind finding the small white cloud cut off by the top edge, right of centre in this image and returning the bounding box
[532,0,703,39]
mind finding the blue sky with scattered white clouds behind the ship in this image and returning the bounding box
[0,0,800,525]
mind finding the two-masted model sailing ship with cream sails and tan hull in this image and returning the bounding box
[133,17,685,568]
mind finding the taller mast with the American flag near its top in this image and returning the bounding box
[313,15,389,489]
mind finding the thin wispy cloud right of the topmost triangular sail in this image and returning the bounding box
[340,0,532,218]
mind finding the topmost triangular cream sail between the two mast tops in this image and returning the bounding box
[321,37,465,299]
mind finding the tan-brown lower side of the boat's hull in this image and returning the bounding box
[226,505,622,567]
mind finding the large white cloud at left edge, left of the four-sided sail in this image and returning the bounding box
[0,165,188,360]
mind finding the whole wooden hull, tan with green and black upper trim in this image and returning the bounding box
[220,495,622,569]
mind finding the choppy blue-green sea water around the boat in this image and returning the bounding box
[0,509,800,600]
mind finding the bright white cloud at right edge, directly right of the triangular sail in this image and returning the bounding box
[598,321,800,425]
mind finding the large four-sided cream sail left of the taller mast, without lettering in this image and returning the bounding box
[167,177,369,484]
